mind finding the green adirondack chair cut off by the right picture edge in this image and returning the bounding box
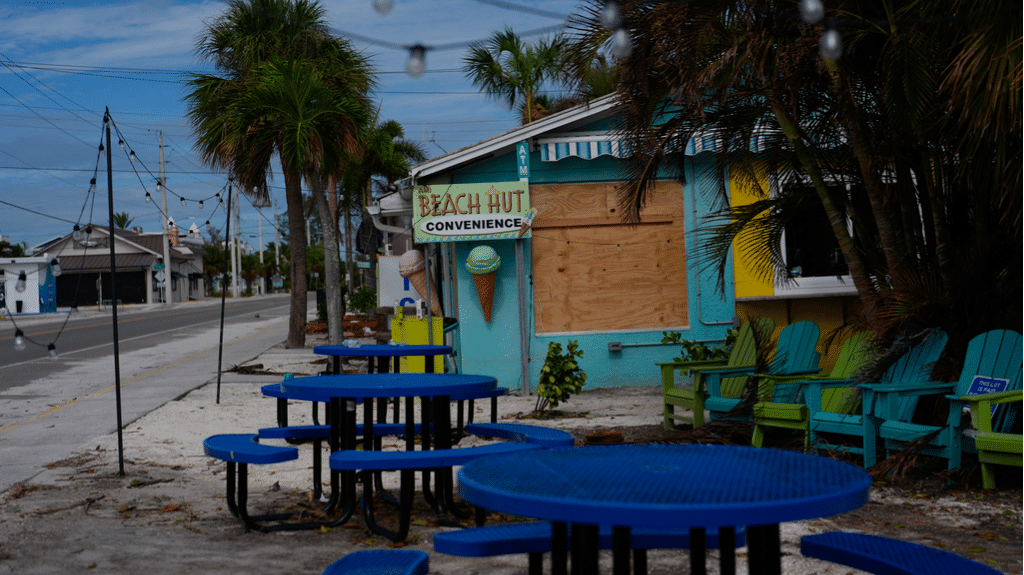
[961,390,1024,489]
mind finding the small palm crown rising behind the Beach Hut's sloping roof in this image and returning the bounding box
[463,28,563,124]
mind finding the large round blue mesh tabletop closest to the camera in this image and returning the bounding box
[459,444,871,529]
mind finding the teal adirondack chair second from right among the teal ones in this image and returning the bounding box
[804,331,949,456]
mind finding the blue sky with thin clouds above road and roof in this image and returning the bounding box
[0,0,577,247]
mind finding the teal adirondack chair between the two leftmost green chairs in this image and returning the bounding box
[693,321,821,419]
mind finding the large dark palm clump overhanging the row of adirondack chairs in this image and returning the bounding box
[569,0,1022,374]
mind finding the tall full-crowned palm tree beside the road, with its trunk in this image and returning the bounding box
[186,0,374,348]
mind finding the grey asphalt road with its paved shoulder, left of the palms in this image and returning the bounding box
[0,295,303,493]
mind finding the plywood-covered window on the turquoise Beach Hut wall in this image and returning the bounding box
[529,182,689,334]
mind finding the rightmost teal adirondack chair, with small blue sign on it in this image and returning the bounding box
[862,329,1024,470]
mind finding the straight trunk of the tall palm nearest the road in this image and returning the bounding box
[282,166,308,349]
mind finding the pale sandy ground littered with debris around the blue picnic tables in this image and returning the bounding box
[0,337,1022,575]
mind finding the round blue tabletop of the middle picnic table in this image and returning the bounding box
[281,373,498,401]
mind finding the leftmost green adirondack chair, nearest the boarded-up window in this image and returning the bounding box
[656,317,775,430]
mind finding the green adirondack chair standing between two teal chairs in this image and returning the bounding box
[751,331,874,450]
